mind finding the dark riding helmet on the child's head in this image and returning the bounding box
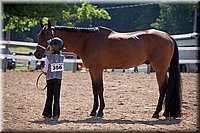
[47,37,64,50]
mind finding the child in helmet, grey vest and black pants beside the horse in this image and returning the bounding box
[42,37,64,120]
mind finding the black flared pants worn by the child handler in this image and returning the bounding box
[42,79,61,118]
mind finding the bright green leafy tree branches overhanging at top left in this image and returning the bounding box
[3,2,111,32]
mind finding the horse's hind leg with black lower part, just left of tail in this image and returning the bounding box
[152,71,168,119]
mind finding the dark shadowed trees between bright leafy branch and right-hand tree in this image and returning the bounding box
[90,3,160,32]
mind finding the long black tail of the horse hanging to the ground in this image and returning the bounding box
[163,38,182,118]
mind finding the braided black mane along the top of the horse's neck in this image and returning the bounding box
[55,26,99,33]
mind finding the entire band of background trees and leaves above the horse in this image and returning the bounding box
[4,3,196,42]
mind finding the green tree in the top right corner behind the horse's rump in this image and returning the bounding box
[151,4,195,34]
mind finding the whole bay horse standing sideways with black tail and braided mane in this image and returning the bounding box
[34,21,182,119]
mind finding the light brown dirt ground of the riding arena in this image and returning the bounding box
[2,71,199,132]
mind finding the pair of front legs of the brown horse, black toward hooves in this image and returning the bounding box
[89,68,105,117]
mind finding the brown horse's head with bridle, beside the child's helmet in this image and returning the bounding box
[34,21,54,59]
